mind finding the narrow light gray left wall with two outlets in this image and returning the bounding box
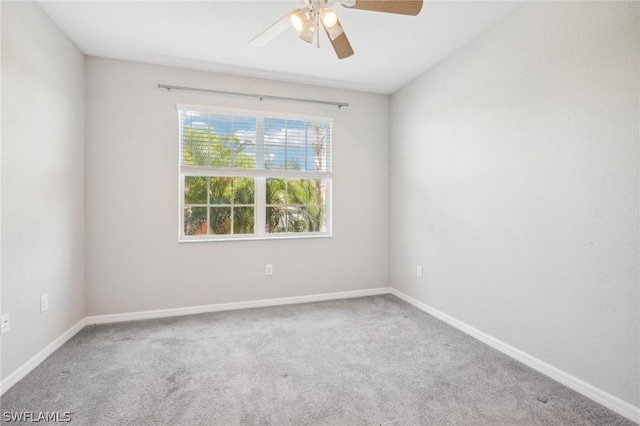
[1,2,85,378]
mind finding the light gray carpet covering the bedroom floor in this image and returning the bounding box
[2,295,634,425]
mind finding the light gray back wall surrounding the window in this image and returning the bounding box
[86,57,390,315]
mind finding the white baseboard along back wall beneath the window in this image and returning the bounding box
[86,287,391,325]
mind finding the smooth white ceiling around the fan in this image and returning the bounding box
[40,0,522,94]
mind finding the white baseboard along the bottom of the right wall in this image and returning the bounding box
[391,288,640,423]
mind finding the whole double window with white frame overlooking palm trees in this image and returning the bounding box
[178,105,331,241]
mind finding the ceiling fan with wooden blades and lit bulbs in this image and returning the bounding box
[249,0,423,59]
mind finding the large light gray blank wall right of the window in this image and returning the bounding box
[391,2,640,406]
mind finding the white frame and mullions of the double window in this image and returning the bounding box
[176,104,333,243]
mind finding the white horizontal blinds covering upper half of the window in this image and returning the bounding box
[180,110,331,173]
